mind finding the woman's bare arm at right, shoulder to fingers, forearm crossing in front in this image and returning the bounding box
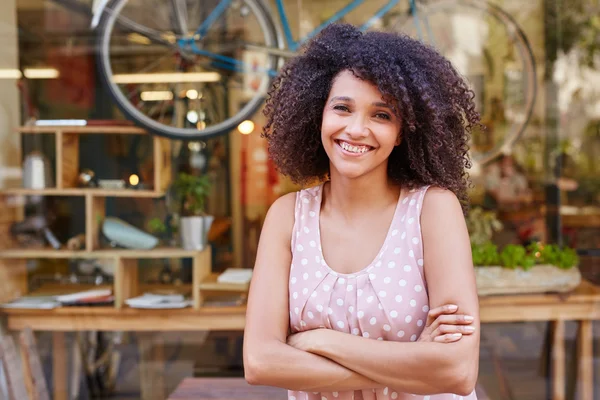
[298,188,479,395]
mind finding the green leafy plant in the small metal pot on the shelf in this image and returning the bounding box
[173,172,211,216]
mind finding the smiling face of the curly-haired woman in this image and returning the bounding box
[321,71,401,179]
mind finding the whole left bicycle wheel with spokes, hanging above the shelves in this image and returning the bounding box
[97,0,281,140]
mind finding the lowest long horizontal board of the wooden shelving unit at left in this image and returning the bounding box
[0,247,208,259]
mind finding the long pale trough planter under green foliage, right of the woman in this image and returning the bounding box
[475,265,581,296]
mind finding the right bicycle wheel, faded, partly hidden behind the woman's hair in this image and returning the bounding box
[384,0,537,164]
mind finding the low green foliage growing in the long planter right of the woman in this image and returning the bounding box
[471,242,579,270]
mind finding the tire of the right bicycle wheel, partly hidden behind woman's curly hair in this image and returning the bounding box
[392,0,538,165]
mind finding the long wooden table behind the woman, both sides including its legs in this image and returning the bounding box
[2,281,600,400]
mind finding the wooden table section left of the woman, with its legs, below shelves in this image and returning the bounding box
[2,306,246,400]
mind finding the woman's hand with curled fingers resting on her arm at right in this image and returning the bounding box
[418,304,475,343]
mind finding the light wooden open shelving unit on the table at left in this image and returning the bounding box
[0,126,223,312]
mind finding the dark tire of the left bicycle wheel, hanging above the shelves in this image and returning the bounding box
[96,0,281,140]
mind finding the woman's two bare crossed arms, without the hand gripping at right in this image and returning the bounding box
[244,188,479,395]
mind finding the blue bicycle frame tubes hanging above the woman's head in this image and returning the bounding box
[177,0,421,76]
